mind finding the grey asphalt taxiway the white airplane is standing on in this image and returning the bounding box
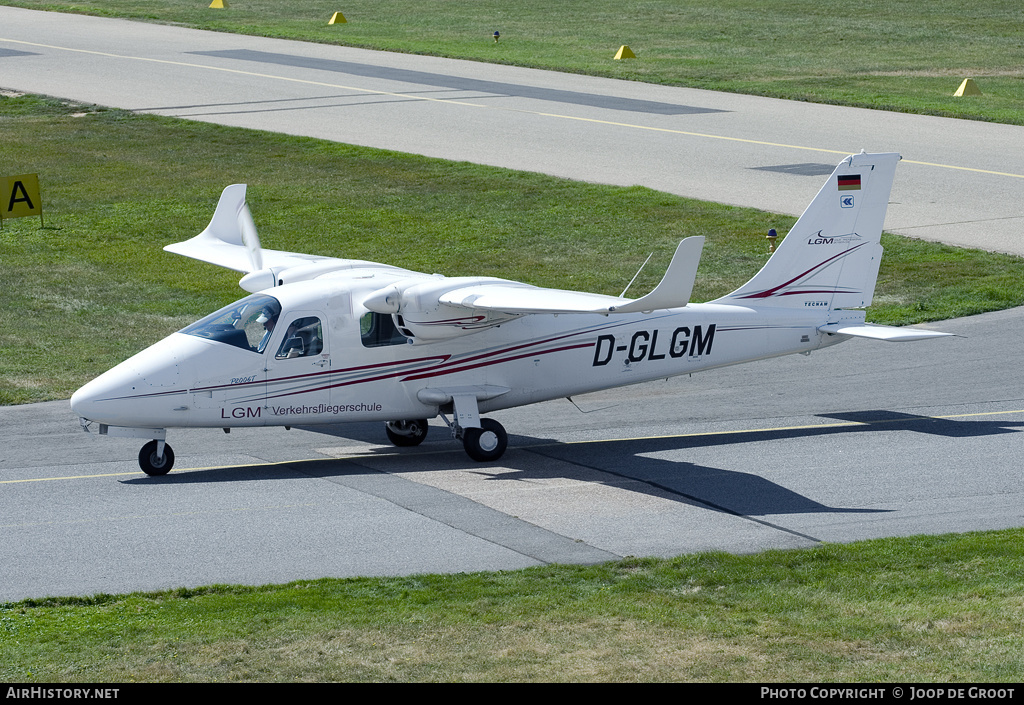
[0,308,1024,600]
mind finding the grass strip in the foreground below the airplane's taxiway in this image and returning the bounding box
[0,530,1024,682]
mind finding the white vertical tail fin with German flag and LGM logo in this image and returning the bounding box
[715,153,900,308]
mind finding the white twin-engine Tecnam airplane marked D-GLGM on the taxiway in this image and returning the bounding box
[71,153,946,475]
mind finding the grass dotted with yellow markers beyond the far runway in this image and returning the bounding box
[2,0,1024,125]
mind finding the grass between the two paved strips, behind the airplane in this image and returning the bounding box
[0,96,1024,404]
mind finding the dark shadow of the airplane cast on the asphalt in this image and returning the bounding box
[124,410,1024,515]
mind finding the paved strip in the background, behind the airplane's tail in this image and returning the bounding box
[0,7,1024,254]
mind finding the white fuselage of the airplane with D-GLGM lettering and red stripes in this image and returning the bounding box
[72,271,845,428]
